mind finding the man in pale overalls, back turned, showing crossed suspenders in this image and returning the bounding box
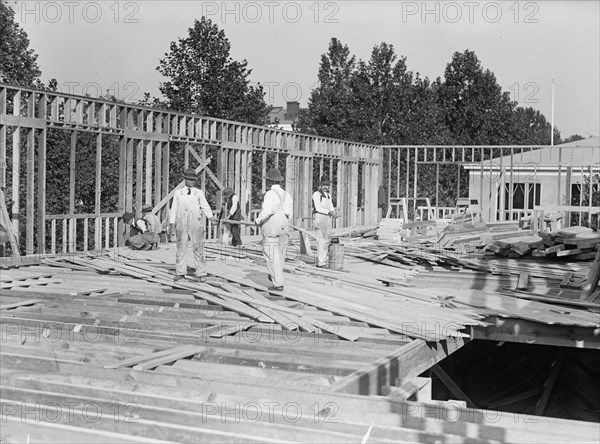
[255,168,293,291]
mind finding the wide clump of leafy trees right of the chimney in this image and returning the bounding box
[296,42,576,145]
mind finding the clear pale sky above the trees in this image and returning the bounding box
[7,0,600,137]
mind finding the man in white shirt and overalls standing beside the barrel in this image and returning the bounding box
[313,176,335,268]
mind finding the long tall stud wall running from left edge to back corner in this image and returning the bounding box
[0,83,382,254]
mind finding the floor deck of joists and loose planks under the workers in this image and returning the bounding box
[0,234,599,442]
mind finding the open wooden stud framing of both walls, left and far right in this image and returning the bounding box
[0,83,596,254]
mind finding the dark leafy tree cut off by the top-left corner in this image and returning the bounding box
[0,2,41,86]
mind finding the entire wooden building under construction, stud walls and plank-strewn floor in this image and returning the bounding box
[0,84,600,443]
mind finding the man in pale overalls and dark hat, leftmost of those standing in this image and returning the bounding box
[169,168,217,282]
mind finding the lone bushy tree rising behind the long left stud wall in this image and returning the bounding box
[157,17,270,124]
